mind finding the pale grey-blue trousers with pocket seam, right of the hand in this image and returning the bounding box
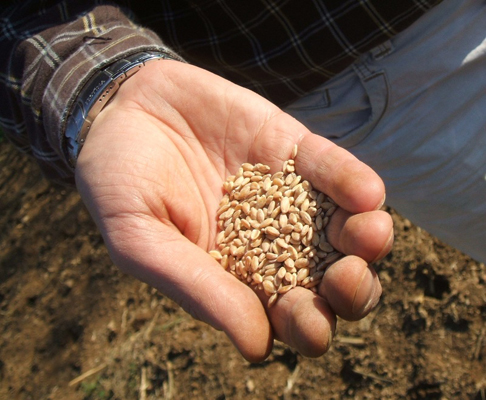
[286,0,486,262]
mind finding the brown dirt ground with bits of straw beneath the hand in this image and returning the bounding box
[0,141,486,400]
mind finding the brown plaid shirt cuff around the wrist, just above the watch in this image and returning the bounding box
[42,6,183,182]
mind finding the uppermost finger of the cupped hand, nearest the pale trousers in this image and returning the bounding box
[251,112,385,213]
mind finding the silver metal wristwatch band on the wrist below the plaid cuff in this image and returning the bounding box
[65,51,174,168]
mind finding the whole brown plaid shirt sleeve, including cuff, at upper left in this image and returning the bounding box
[0,0,179,184]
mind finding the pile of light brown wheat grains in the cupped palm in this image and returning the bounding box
[210,146,342,306]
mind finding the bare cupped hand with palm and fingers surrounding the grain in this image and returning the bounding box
[76,61,393,362]
